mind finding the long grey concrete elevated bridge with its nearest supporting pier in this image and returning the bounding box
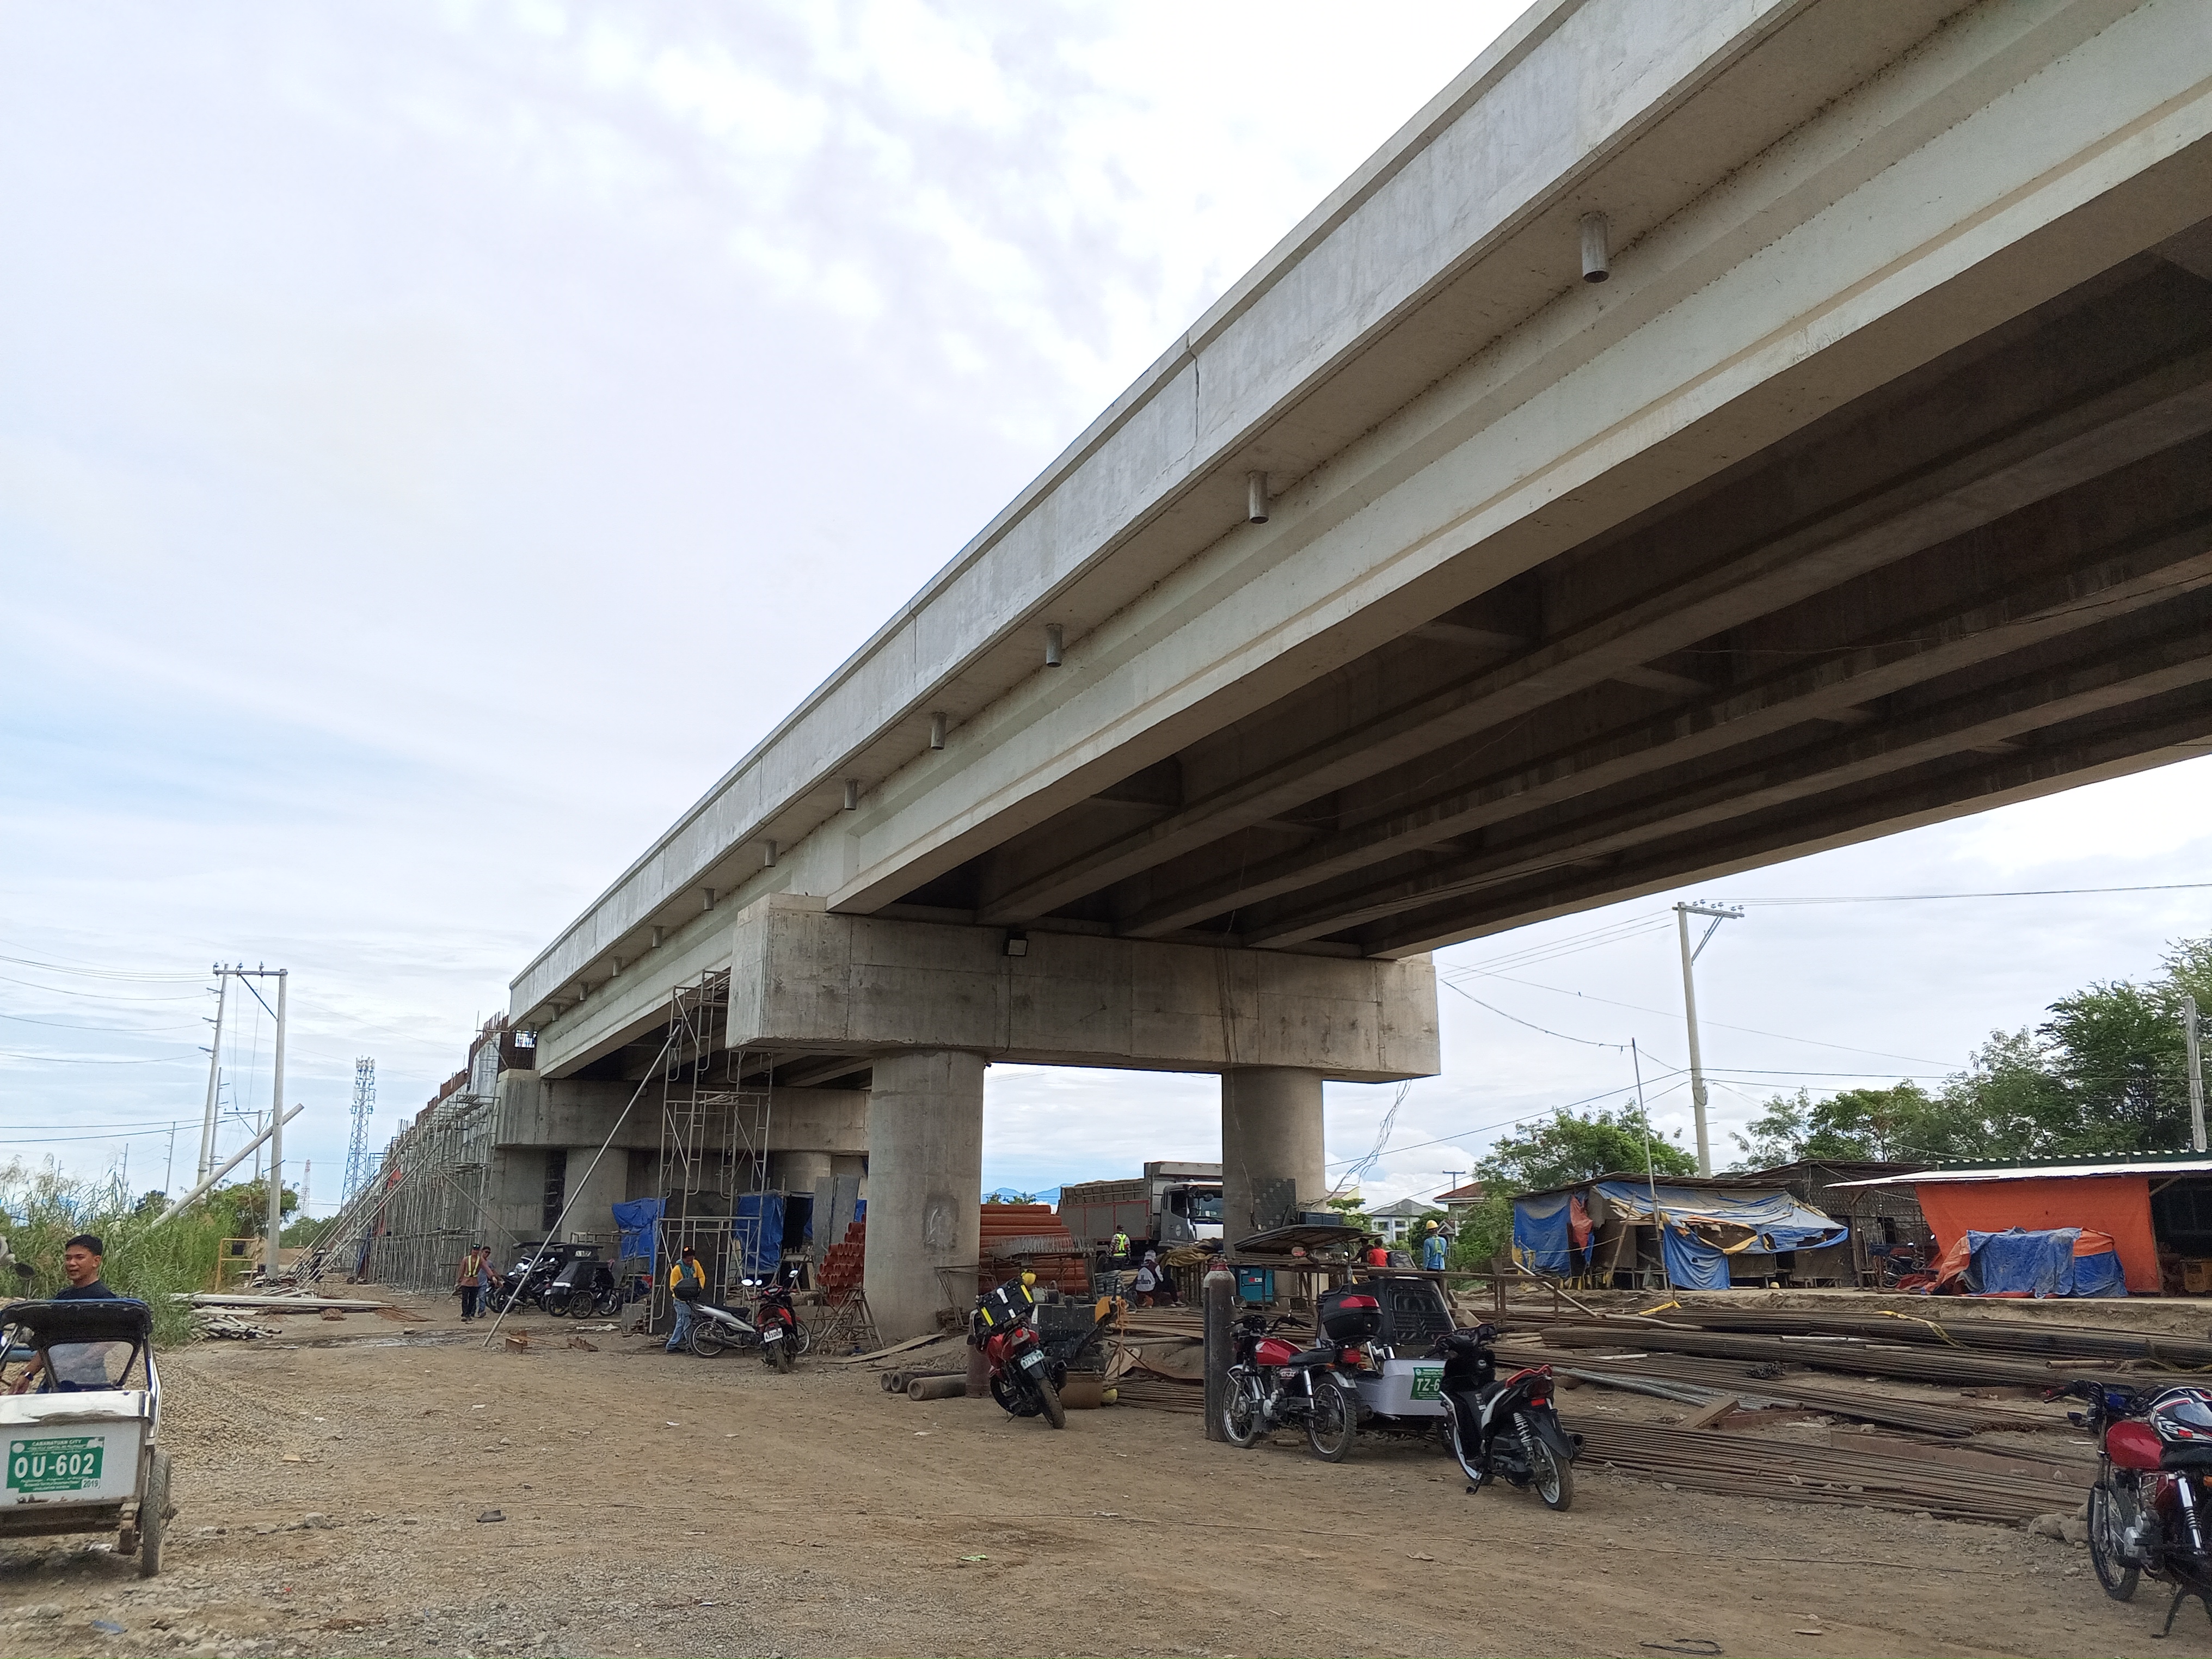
[484,0,2212,1336]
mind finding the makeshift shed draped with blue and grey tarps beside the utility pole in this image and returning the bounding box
[1513,1175,1856,1289]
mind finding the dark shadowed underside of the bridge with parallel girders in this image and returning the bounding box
[929,236,2212,956]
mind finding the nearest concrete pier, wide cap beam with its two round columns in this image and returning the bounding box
[730,894,1438,1343]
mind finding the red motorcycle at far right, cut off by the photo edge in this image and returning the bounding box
[2046,1380,2212,1635]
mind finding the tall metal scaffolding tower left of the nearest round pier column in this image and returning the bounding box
[653,969,783,1329]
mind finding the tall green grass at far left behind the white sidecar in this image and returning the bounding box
[0,1159,254,1347]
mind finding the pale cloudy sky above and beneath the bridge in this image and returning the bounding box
[13,0,2212,1212]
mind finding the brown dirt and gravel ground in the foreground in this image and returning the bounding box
[0,1303,2212,1659]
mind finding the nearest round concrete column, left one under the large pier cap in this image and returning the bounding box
[865,1048,984,1343]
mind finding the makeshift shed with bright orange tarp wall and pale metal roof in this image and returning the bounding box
[1852,1152,2212,1297]
